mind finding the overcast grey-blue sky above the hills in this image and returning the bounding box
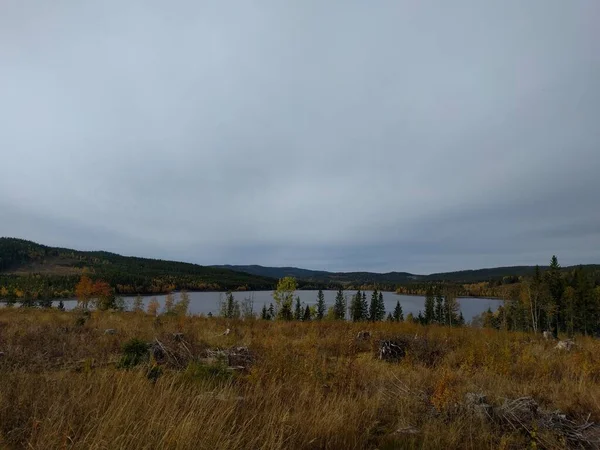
[0,0,600,273]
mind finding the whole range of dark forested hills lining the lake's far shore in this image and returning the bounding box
[0,238,600,297]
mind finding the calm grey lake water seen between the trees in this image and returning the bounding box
[49,291,502,321]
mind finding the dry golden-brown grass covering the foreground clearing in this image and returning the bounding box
[0,309,600,450]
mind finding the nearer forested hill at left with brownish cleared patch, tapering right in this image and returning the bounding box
[0,238,276,297]
